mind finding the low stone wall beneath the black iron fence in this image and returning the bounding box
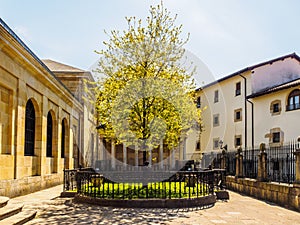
[226,176,300,212]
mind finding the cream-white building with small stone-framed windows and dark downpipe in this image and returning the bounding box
[197,53,300,155]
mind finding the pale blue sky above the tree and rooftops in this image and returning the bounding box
[0,0,300,84]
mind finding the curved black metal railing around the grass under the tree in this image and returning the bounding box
[64,170,226,199]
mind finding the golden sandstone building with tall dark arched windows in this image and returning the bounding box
[0,19,97,197]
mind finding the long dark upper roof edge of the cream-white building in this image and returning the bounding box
[196,52,300,91]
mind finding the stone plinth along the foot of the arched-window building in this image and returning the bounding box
[0,173,63,198]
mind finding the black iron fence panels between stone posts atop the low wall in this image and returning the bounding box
[201,140,300,184]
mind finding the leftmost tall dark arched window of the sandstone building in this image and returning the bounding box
[24,100,35,156]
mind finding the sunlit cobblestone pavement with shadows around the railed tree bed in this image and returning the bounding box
[11,186,300,225]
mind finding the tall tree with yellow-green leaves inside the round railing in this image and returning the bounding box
[87,3,201,162]
